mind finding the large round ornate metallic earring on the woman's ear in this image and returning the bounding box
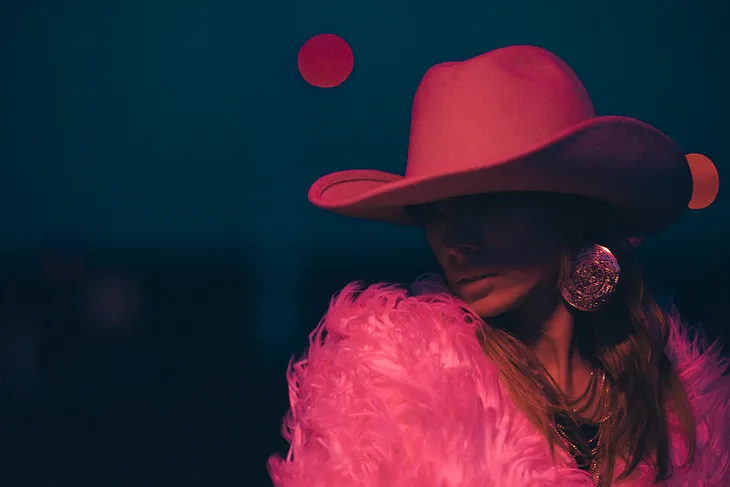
[558,245,621,311]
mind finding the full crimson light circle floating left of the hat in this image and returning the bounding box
[297,34,355,88]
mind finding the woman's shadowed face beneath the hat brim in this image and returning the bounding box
[419,193,569,318]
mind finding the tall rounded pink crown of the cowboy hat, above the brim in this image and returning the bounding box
[405,46,595,177]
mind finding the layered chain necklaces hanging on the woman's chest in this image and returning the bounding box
[551,371,611,485]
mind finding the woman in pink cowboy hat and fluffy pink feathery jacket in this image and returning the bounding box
[269,46,730,487]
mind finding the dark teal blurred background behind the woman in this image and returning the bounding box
[0,0,730,486]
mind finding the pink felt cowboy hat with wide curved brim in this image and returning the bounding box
[309,46,692,236]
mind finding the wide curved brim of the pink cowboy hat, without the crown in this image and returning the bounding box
[308,116,692,236]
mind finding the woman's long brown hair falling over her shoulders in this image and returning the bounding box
[480,198,696,486]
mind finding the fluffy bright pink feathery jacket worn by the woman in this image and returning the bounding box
[268,280,730,487]
